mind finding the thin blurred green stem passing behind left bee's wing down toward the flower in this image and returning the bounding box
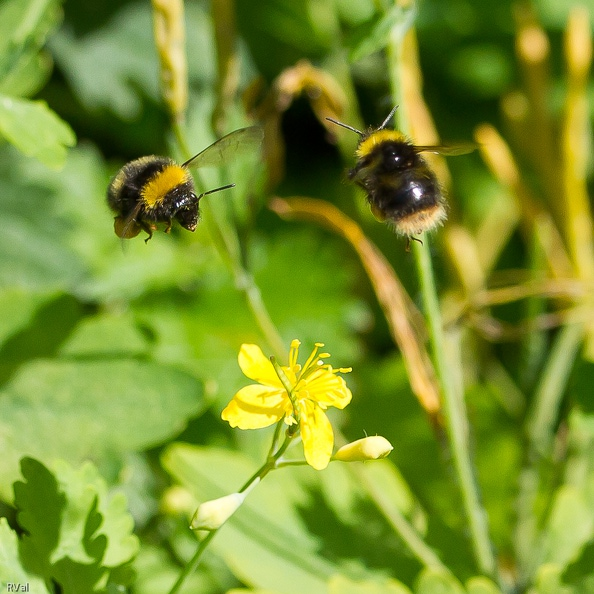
[172,121,286,358]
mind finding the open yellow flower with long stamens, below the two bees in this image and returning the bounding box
[221,340,352,470]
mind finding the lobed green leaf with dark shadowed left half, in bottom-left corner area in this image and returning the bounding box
[14,458,138,594]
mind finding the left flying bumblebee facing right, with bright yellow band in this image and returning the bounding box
[107,126,263,243]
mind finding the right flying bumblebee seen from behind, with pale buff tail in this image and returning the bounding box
[326,106,476,240]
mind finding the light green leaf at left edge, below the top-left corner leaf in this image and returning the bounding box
[0,95,76,169]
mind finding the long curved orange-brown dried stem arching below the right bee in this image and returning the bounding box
[270,198,440,420]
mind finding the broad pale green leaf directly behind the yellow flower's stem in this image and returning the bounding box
[162,444,339,594]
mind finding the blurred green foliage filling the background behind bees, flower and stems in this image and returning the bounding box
[0,0,594,594]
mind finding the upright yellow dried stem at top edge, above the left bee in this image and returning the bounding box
[152,0,188,121]
